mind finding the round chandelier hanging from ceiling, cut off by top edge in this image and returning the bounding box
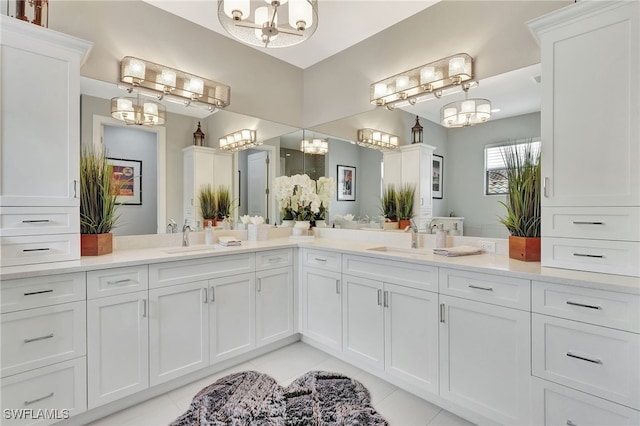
[218,0,318,47]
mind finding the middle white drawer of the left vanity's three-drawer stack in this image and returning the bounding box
[0,302,87,377]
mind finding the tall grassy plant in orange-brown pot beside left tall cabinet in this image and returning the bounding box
[80,145,126,256]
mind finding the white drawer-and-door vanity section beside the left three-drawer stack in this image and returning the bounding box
[87,265,149,409]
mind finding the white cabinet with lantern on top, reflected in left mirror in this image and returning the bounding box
[182,146,233,228]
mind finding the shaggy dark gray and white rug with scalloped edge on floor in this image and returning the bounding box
[171,371,388,426]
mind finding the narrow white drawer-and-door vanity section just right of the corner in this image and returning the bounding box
[301,248,342,352]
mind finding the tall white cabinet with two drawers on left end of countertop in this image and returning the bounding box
[0,15,92,266]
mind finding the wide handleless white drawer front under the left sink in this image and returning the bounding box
[149,253,256,288]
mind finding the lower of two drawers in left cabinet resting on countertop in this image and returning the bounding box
[0,234,80,266]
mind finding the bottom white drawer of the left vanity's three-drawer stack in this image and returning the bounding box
[1,357,87,425]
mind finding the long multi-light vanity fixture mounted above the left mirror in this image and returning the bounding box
[120,56,231,112]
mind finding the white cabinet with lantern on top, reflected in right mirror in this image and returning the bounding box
[382,144,436,230]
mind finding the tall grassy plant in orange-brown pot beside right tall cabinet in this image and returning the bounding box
[499,143,540,261]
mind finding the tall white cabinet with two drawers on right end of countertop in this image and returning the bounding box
[529,1,640,276]
